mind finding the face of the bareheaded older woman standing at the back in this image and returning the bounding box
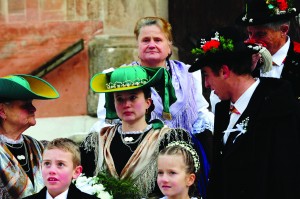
[138,25,171,67]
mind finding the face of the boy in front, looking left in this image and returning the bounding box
[42,149,82,197]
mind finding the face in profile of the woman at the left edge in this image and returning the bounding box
[1,100,36,130]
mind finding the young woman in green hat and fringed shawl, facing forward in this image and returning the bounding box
[81,66,199,197]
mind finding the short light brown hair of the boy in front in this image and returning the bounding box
[45,138,81,168]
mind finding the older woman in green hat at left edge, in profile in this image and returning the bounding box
[0,75,59,199]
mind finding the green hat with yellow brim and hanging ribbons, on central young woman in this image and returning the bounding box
[90,66,177,119]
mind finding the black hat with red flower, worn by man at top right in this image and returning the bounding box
[237,0,299,26]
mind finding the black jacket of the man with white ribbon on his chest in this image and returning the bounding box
[208,78,300,199]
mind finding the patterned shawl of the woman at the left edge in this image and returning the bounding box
[0,135,44,199]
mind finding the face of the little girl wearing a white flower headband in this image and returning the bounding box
[157,155,195,199]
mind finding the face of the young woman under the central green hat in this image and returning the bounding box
[114,89,152,124]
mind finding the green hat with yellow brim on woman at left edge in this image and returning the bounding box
[0,74,59,100]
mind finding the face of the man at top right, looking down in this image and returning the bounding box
[247,26,286,55]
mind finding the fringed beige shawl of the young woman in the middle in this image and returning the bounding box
[84,125,191,197]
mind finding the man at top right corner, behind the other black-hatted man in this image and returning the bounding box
[237,0,300,103]
